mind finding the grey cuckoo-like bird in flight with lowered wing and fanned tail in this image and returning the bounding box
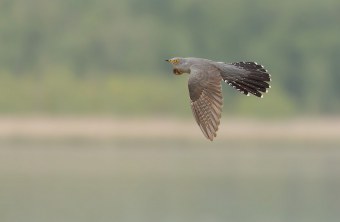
[165,57,271,141]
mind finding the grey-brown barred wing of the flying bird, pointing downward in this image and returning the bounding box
[188,66,223,141]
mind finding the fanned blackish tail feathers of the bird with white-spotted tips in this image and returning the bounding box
[222,62,271,98]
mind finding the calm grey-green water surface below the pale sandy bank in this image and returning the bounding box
[0,139,340,222]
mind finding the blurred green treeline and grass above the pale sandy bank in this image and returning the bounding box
[0,0,340,116]
